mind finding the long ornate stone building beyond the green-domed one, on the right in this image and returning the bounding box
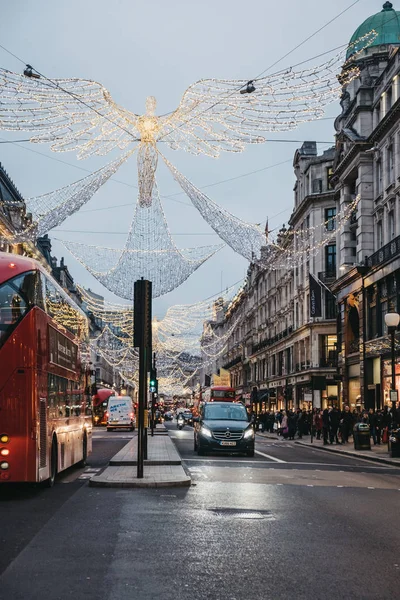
[213,142,338,409]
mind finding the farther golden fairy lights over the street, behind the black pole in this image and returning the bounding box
[78,286,239,391]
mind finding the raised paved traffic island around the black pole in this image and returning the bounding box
[89,426,192,488]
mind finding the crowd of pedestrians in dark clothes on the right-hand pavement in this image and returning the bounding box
[254,406,400,445]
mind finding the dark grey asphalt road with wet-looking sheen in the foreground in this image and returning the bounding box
[0,424,400,600]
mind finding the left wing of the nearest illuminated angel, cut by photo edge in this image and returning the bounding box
[0,68,138,158]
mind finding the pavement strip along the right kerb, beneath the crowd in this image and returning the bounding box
[257,432,400,467]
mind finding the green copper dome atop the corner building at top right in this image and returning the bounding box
[346,2,400,58]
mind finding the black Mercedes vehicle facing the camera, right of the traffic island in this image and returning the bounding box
[194,402,255,456]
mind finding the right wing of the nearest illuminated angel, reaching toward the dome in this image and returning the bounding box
[158,32,376,157]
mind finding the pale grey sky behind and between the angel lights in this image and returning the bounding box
[0,0,382,315]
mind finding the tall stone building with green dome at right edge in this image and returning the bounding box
[332,2,400,408]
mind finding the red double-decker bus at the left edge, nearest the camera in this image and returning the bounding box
[0,252,92,486]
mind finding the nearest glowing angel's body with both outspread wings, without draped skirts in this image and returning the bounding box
[0,31,377,201]
